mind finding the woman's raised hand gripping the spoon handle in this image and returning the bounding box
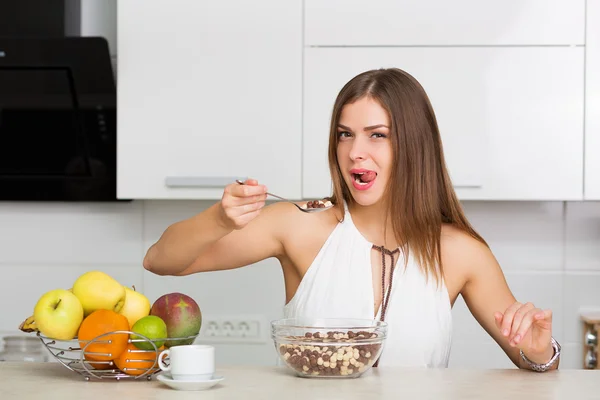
[220,179,267,229]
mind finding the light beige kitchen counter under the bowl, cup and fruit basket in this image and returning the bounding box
[0,362,600,400]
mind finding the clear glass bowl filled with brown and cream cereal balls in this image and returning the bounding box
[271,318,387,378]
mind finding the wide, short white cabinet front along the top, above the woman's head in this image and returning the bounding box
[305,0,589,46]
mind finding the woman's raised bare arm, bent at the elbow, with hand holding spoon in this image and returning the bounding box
[143,181,289,275]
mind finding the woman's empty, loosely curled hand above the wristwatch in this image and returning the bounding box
[494,302,553,363]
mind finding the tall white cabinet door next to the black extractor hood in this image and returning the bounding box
[118,0,302,199]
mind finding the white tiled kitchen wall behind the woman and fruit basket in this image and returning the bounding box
[0,0,600,368]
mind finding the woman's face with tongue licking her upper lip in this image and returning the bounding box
[337,97,393,206]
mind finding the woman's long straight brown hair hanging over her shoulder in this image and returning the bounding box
[329,68,487,283]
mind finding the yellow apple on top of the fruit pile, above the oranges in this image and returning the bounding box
[73,271,125,316]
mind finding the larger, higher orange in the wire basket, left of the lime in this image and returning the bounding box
[77,310,129,362]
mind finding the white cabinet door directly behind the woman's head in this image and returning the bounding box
[303,47,583,200]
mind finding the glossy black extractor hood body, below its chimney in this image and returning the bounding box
[0,36,122,201]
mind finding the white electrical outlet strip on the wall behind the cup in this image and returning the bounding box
[198,315,269,343]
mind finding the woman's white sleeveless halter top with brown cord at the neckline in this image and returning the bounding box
[284,208,452,368]
